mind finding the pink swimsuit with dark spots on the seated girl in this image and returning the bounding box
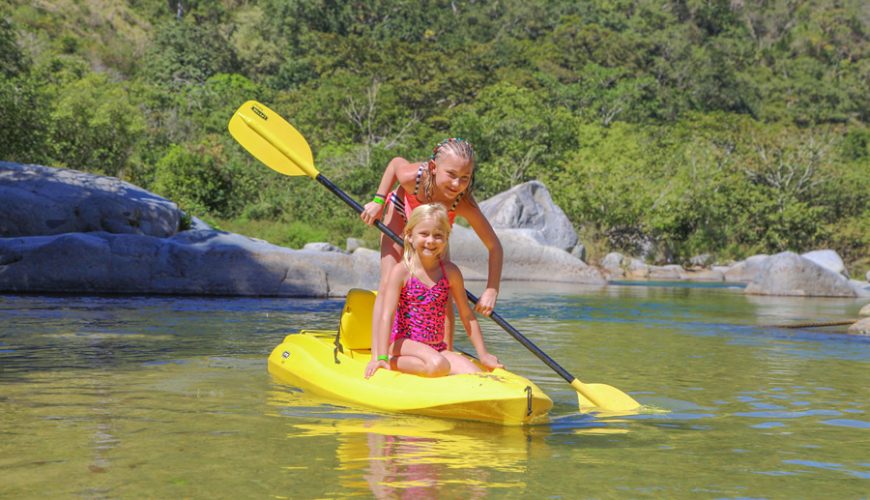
[390,261,450,352]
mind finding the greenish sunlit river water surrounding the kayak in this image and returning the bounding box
[0,283,870,498]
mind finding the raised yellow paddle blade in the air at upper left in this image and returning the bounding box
[229,101,318,179]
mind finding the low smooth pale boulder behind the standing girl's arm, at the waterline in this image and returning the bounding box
[450,225,606,284]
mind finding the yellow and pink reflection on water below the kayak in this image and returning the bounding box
[290,417,532,498]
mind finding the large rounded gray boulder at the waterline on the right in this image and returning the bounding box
[744,252,856,297]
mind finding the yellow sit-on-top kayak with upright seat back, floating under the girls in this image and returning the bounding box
[269,289,553,425]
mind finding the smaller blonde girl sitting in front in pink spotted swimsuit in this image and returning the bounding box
[365,203,502,378]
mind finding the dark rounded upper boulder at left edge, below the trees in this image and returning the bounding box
[0,162,182,238]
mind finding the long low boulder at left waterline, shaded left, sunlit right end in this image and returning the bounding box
[0,231,379,297]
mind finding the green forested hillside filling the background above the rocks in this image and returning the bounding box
[0,0,870,273]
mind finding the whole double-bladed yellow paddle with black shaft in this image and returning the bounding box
[229,101,640,412]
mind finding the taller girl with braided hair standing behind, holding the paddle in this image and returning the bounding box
[360,138,503,349]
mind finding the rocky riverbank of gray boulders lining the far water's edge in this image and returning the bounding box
[0,162,870,320]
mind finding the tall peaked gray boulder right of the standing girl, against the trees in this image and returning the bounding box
[480,181,579,252]
